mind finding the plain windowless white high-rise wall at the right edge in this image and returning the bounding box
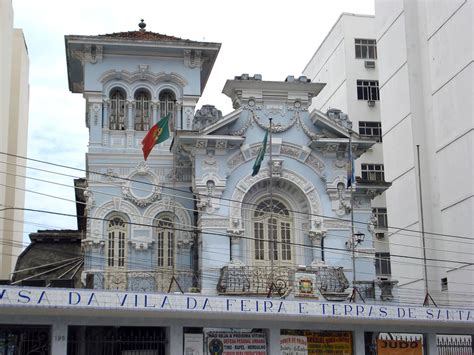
[375,0,474,306]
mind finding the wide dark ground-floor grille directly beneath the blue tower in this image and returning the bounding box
[67,326,166,355]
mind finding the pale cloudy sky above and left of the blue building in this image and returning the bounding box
[13,0,374,243]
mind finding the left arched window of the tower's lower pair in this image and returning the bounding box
[107,217,127,268]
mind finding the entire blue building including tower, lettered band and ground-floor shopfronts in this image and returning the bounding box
[0,16,474,355]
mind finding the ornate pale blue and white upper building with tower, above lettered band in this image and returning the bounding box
[66,22,386,300]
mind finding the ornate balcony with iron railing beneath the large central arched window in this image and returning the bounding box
[217,264,349,301]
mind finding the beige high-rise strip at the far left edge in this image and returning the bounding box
[0,0,29,279]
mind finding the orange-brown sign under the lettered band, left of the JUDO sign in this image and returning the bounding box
[305,331,352,355]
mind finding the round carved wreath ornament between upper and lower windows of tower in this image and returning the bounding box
[122,162,161,207]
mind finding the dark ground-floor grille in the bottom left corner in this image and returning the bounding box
[0,325,50,355]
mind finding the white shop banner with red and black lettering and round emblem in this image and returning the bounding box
[206,332,267,355]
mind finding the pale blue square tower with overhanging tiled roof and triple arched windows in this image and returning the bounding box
[66,20,220,291]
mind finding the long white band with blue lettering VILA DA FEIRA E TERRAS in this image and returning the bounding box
[0,286,474,324]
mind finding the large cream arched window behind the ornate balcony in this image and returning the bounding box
[253,199,294,264]
